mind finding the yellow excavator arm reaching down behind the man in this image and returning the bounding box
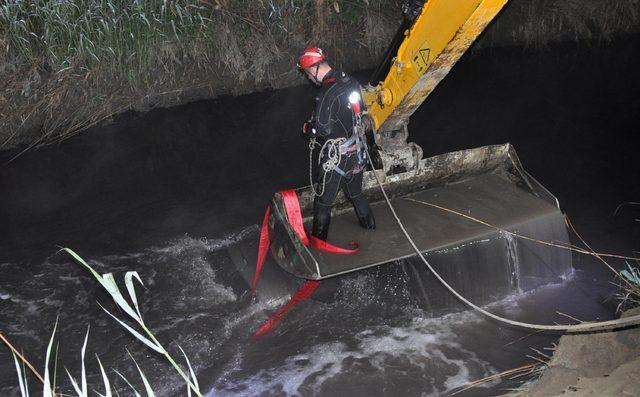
[364,0,508,133]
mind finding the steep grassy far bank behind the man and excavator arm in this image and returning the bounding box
[0,0,639,149]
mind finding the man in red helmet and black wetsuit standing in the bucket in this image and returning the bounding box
[298,47,376,241]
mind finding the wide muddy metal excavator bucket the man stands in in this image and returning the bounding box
[268,144,571,289]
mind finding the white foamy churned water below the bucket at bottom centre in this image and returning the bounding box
[209,313,494,396]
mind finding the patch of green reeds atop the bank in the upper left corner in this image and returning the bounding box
[0,0,214,77]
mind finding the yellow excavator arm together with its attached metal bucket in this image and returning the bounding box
[249,0,571,313]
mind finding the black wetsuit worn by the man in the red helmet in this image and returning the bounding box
[312,70,375,240]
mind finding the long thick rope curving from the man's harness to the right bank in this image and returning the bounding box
[367,148,640,332]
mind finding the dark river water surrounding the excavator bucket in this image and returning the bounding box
[0,37,640,396]
